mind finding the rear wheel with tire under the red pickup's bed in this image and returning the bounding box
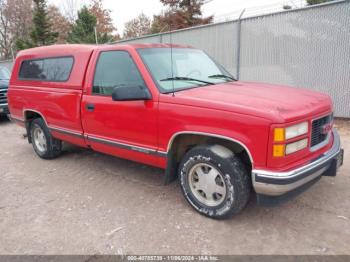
[30,118,62,159]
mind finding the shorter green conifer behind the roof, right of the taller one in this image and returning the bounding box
[67,6,111,44]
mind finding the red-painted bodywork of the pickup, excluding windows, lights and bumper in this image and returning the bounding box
[8,44,332,171]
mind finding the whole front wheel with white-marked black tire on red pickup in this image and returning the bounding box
[179,145,251,219]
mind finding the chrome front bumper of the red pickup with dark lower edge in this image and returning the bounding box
[252,129,343,205]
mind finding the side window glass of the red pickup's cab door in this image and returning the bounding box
[92,51,146,96]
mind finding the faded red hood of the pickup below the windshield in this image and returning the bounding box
[161,82,332,123]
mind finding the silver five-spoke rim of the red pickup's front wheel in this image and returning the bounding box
[188,163,227,207]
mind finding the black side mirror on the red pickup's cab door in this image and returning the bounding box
[112,86,152,101]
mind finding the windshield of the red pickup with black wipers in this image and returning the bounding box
[138,48,234,93]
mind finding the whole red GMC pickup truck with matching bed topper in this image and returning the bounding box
[8,44,343,218]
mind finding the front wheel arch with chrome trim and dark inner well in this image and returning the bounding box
[165,131,254,184]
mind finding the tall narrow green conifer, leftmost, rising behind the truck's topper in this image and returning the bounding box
[16,0,58,50]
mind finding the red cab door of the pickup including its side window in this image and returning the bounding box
[82,50,158,164]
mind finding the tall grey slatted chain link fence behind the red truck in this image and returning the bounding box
[0,1,350,118]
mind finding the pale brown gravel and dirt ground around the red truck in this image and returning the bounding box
[0,117,350,254]
